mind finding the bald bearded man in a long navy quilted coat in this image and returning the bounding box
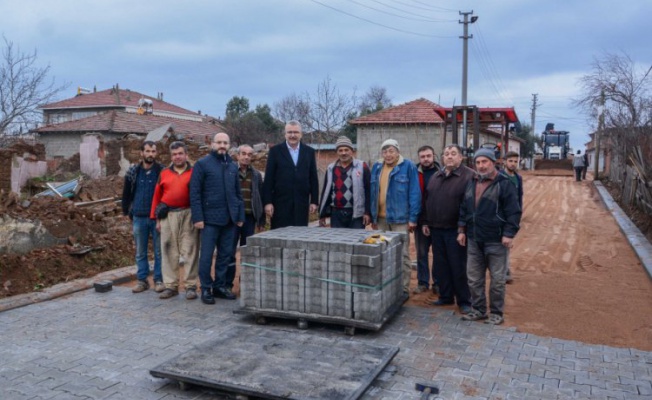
[190,133,244,304]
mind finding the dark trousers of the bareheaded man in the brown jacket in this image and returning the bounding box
[430,228,471,307]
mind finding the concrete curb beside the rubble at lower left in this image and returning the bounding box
[0,266,136,312]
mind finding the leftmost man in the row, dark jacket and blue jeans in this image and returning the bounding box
[122,141,165,293]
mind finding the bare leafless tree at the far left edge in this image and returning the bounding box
[0,36,68,134]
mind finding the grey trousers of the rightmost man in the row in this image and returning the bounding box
[466,238,507,316]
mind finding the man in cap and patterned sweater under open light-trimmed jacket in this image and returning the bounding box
[319,136,371,229]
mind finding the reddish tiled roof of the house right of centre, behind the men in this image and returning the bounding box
[349,98,443,125]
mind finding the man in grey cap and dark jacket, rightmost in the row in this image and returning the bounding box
[457,148,521,325]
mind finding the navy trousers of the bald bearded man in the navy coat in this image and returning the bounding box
[199,222,235,290]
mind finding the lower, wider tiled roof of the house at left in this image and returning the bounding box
[31,110,225,140]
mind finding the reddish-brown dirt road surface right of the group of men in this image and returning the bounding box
[410,174,652,351]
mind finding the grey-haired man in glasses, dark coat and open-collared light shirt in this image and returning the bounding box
[263,121,319,229]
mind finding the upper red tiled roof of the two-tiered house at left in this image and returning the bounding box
[40,88,197,115]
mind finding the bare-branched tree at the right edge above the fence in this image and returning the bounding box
[575,53,652,162]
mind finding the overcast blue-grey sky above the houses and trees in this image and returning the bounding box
[0,0,652,149]
